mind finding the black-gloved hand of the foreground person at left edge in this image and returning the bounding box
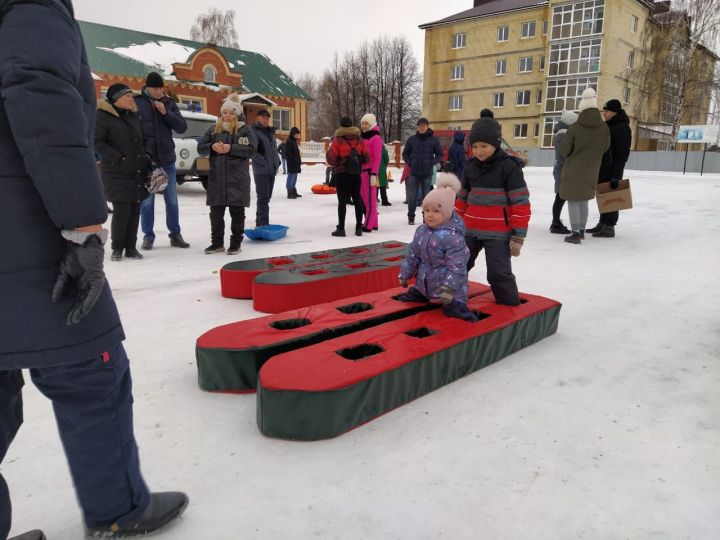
[52,234,105,326]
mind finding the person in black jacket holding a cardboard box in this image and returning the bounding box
[587,99,632,238]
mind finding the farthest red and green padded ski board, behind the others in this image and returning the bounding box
[220,240,407,298]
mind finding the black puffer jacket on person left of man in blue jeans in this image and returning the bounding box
[95,100,150,202]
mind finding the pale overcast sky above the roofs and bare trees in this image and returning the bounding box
[73,0,466,76]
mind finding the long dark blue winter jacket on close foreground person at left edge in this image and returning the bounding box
[0,0,125,370]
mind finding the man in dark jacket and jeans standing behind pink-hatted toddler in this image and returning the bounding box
[403,118,442,225]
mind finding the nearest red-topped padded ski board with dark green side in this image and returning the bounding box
[257,294,561,440]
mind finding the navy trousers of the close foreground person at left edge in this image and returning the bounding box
[0,343,150,538]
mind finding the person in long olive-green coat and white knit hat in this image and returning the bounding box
[559,88,610,244]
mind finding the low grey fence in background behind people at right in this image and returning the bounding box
[516,148,720,173]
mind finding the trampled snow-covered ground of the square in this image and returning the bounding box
[2,166,720,540]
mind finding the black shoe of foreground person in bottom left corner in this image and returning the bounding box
[86,491,190,538]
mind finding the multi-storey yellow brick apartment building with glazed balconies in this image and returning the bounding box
[420,0,714,148]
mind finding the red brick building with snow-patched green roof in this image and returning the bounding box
[79,21,310,139]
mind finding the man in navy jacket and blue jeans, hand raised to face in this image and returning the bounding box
[135,72,190,249]
